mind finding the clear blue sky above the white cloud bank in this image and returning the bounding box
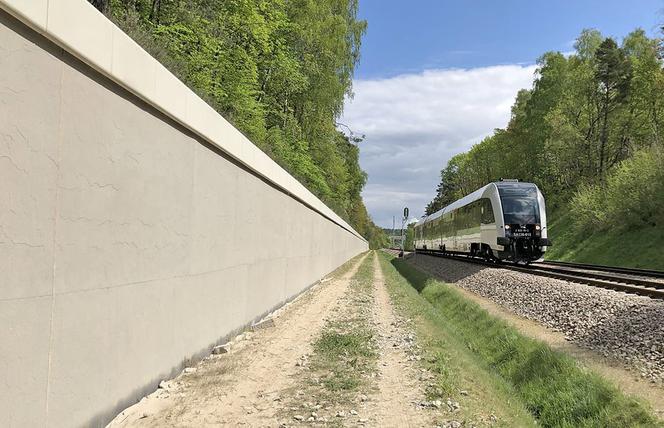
[356,0,664,79]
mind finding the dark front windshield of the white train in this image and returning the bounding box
[498,184,540,224]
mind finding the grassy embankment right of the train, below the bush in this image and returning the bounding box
[545,210,664,270]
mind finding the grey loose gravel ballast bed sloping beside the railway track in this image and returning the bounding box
[409,254,664,384]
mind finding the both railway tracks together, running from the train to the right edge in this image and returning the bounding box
[418,250,664,299]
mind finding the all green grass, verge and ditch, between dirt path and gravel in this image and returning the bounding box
[381,255,662,427]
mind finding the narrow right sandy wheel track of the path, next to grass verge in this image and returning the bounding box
[372,252,433,427]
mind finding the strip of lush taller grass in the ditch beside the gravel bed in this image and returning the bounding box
[382,254,664,427]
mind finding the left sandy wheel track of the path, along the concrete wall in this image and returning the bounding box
[110,255,366,427]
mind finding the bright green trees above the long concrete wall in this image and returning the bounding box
[89,0,386,248]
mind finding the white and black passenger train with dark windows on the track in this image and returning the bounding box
[414,180,552,264]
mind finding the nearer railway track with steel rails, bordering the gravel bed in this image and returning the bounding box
[416,250,664,299]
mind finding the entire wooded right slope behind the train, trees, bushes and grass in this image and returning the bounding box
[426,29,664,267]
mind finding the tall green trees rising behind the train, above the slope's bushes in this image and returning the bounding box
[427,29,664,224]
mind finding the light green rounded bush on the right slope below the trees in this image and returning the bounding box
[571,147,664,234]
